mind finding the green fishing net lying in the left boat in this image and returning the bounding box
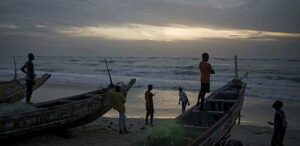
[0,102,36,117]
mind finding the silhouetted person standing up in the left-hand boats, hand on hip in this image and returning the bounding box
[21,53,35,103]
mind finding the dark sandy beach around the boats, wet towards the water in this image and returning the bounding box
[1,84,300,146]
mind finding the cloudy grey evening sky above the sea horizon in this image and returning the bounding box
[0,0,300,59]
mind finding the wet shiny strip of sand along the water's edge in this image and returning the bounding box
[32,83,300,129]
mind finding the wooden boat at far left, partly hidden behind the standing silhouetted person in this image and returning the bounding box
[0,73,51,103]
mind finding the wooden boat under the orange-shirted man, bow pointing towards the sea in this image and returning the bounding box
[176,79,246,146]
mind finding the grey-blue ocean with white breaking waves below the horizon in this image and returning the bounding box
[0,56,300,101]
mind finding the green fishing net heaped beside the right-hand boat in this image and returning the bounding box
[143,121,184,146]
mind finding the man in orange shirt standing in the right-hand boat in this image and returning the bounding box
[197,53,215,110]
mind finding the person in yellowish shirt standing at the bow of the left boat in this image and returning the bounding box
[109,86,128,134]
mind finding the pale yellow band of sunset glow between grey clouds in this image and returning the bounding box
[58,24,300,41]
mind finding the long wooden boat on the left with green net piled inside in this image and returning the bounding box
[0,79,135,141]
